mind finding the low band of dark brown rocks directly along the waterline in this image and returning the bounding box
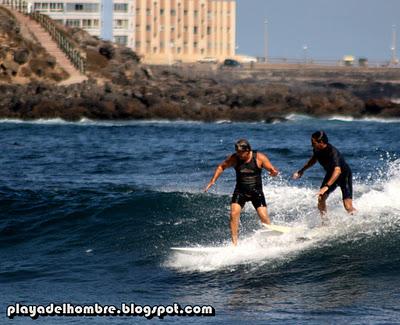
[0,74,400,122]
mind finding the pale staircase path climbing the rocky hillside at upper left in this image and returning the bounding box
[12,10,87,85]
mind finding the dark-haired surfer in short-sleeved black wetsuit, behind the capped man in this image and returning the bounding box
[293,131,356,223]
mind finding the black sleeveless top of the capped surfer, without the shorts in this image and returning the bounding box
[235,151,262,193]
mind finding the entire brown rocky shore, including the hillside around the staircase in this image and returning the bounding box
[0,9,400,122]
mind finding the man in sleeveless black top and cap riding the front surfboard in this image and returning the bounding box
[205,139,278,246]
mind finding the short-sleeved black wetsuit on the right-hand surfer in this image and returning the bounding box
[314,143,353,200]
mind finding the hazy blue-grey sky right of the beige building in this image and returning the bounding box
[237,0,400,61]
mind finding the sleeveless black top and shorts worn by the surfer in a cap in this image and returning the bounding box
[231,151,267,209]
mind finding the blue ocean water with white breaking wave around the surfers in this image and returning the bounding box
[0,116,400,324]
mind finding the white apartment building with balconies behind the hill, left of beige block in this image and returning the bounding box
[28,0,135,48]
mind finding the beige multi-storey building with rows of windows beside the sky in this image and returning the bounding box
[134,0,236,64]
